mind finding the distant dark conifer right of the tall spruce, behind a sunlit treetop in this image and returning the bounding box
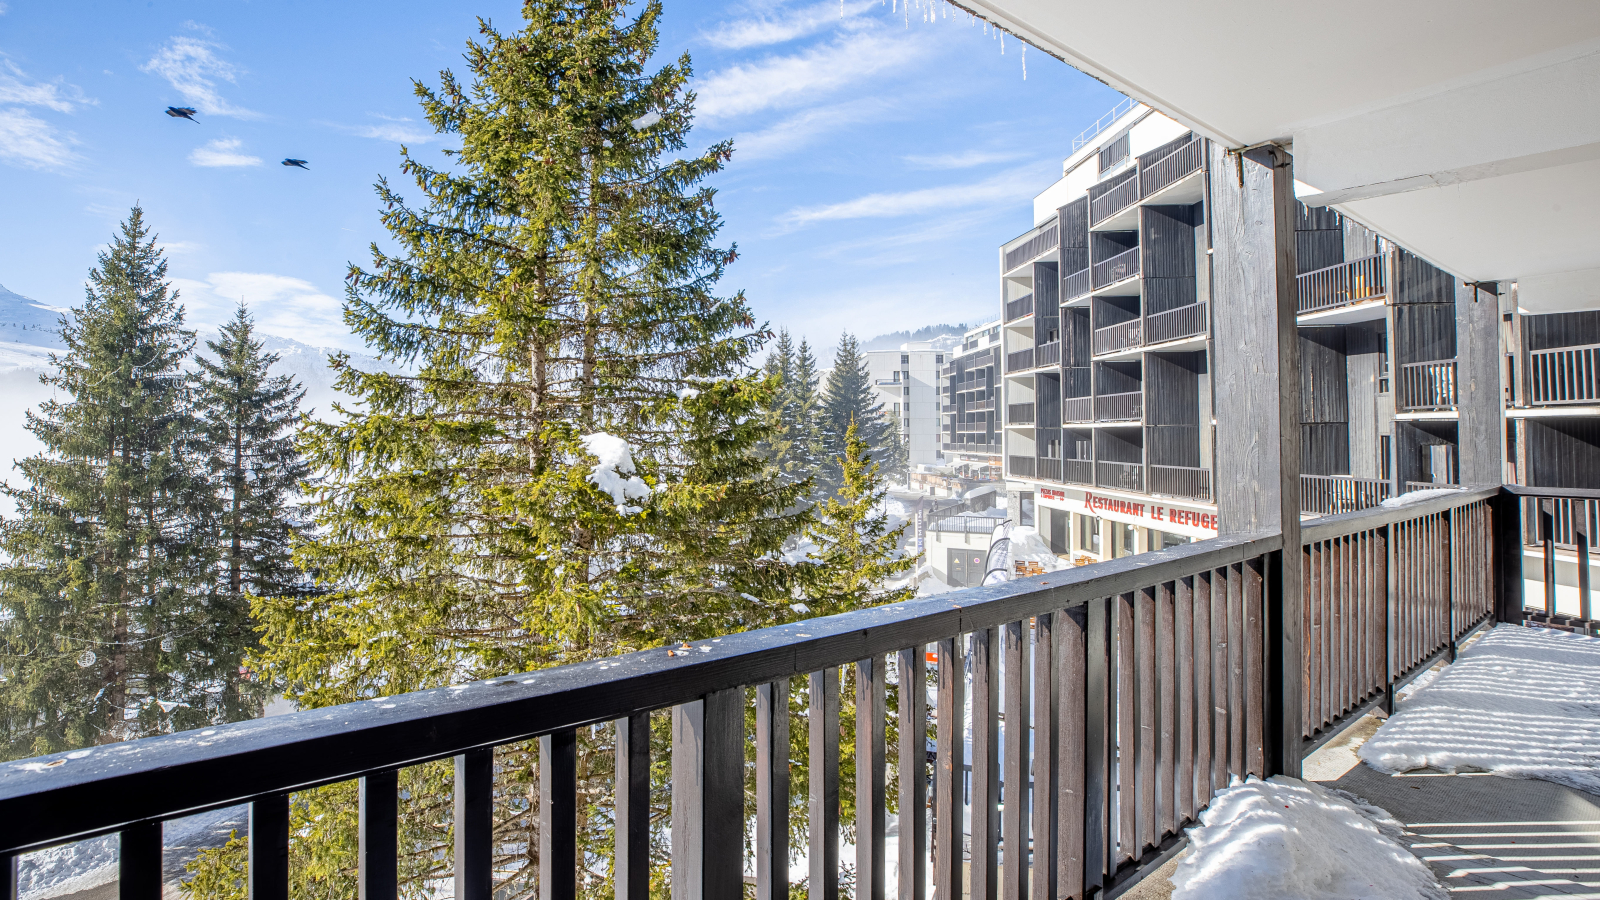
[819,331,904,496]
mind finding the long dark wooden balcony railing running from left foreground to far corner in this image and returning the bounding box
[0,488,1523,900]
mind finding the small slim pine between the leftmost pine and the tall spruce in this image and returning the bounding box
[195,303,310,604]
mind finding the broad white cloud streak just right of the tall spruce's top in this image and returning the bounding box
[694,32,922,122]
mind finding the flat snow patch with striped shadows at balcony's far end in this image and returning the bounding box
[1362,625,1600,793]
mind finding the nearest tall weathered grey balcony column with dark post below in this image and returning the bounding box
[1208,144,1302,777]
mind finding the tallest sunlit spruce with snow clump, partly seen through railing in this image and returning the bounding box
[211,0,819,898]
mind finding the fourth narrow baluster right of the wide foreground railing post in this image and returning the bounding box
[902,647,928,900]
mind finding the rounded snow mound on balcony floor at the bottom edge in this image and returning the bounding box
[1173,775,1446,900]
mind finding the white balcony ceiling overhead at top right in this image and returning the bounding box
[966,0,1600,311]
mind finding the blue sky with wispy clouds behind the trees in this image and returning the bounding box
[0,0,1118,349]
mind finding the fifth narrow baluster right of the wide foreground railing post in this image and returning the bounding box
[933,637,966,898]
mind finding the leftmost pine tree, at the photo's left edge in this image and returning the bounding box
[0,207,252,757]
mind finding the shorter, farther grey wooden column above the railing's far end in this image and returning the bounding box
[1456,282,1506,485]
